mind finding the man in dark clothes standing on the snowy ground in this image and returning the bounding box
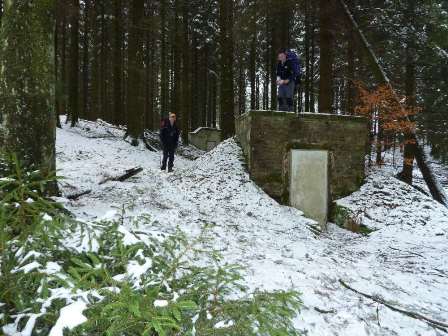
[159,113,180,172]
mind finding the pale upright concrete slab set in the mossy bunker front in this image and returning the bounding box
[289,149,329,229]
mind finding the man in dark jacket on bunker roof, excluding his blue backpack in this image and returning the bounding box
[277,49,295,112]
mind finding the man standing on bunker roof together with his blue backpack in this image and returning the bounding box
[277,48,300,112]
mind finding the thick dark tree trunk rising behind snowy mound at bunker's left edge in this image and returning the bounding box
[219,0,235,139]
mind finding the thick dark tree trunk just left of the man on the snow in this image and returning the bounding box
[126,0,145,145]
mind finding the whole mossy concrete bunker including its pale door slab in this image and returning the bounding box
[236,111,369,228]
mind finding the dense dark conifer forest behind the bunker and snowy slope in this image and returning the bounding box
[0,0,447,155]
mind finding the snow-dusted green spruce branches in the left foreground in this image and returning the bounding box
[0,155,301,336]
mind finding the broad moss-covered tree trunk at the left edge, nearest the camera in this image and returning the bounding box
[0,1,57,194]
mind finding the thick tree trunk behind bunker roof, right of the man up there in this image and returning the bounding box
[319,0,333,113]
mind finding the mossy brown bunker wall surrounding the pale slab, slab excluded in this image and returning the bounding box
[236,111,368,204]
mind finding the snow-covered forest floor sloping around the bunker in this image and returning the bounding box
[57,122,448,335]
